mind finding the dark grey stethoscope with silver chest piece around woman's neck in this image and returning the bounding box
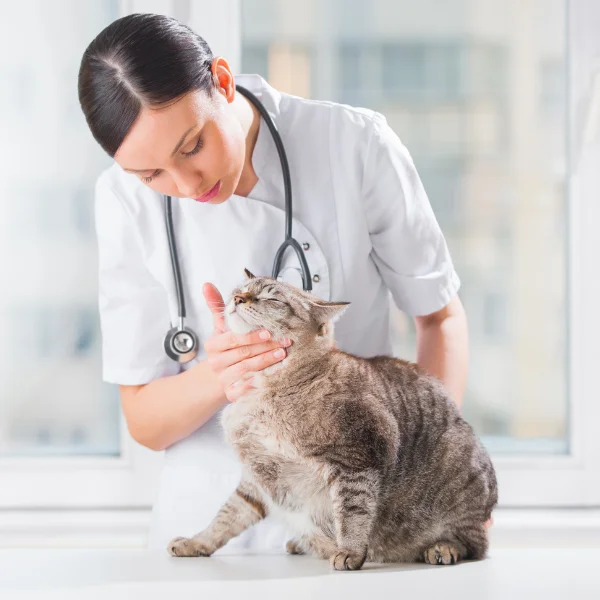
[164,85,312,363]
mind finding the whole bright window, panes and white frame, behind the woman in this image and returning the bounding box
[0,0,600,520]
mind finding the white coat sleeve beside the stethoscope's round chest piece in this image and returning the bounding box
[95,176,180,385]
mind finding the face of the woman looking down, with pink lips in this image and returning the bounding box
[114,72,246,204]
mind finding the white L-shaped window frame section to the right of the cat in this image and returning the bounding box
[239,0,600,508]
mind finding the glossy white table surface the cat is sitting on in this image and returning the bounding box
[0,547,600,600]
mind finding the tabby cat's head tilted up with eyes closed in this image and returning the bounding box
[225,269,350,342]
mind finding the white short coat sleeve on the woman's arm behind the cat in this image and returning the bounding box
[362,113,460,316]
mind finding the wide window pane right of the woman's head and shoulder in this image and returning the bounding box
[241,0,568,453]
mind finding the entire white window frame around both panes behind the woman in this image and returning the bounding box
[0,0,600,509]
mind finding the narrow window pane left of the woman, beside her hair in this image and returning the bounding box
[0,0,120,457]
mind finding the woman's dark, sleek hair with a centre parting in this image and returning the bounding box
[78,14,214,156]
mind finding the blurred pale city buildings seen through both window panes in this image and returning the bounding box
[0,0,568,457]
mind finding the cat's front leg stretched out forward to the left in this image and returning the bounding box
[168,480,267,556]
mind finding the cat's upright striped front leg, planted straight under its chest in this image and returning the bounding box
[329,469,380,571]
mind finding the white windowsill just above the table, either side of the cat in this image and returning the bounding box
[0,508,600,548]
